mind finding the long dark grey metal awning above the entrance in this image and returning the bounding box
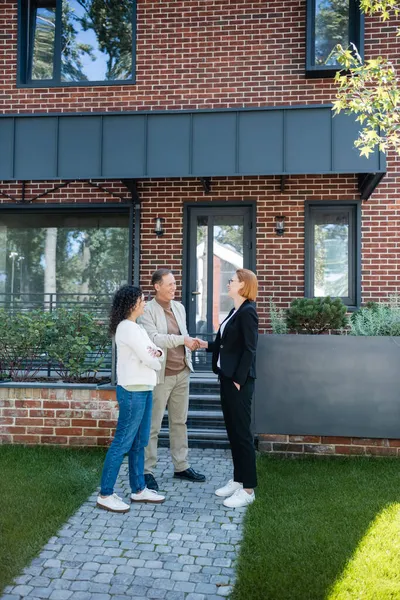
[0,106,386,196]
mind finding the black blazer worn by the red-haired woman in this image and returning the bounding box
[208,300,258,385]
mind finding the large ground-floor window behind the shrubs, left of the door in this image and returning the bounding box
[0,207,130,307]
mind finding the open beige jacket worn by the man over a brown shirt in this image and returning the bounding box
[138,298,193,383]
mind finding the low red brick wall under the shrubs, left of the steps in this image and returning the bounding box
[0,387,117,446]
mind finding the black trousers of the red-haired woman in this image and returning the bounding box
[219,375,257,489]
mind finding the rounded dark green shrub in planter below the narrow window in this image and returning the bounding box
[286,296,348,334]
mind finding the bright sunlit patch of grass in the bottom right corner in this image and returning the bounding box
[327,503,400,600]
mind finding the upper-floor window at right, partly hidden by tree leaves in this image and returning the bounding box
[306,0,364,77]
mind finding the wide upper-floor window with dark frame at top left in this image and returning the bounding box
[19,0,136,87]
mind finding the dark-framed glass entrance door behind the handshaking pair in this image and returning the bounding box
[187,206,252,340]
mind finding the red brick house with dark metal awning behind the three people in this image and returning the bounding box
[0,0,400,450]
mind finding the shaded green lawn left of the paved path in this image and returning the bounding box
[0,446,105,592]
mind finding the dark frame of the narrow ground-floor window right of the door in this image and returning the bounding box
[304,200,361,311]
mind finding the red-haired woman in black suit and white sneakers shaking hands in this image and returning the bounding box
[201,269,258,508]
